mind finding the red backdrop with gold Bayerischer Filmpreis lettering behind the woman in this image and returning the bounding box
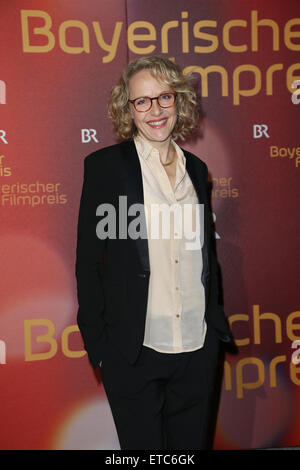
[0,0,300,449]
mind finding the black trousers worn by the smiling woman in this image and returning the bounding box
[101,327,219,450]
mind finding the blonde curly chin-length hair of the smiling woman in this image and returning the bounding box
[108,56,199,140]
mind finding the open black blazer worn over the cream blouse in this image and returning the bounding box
[76,140,232,367]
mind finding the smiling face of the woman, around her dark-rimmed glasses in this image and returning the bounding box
[129,70,177,148]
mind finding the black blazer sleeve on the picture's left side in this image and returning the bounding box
[75,154,106,368]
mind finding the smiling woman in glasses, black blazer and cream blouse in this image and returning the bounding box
[76,56,232,449]
